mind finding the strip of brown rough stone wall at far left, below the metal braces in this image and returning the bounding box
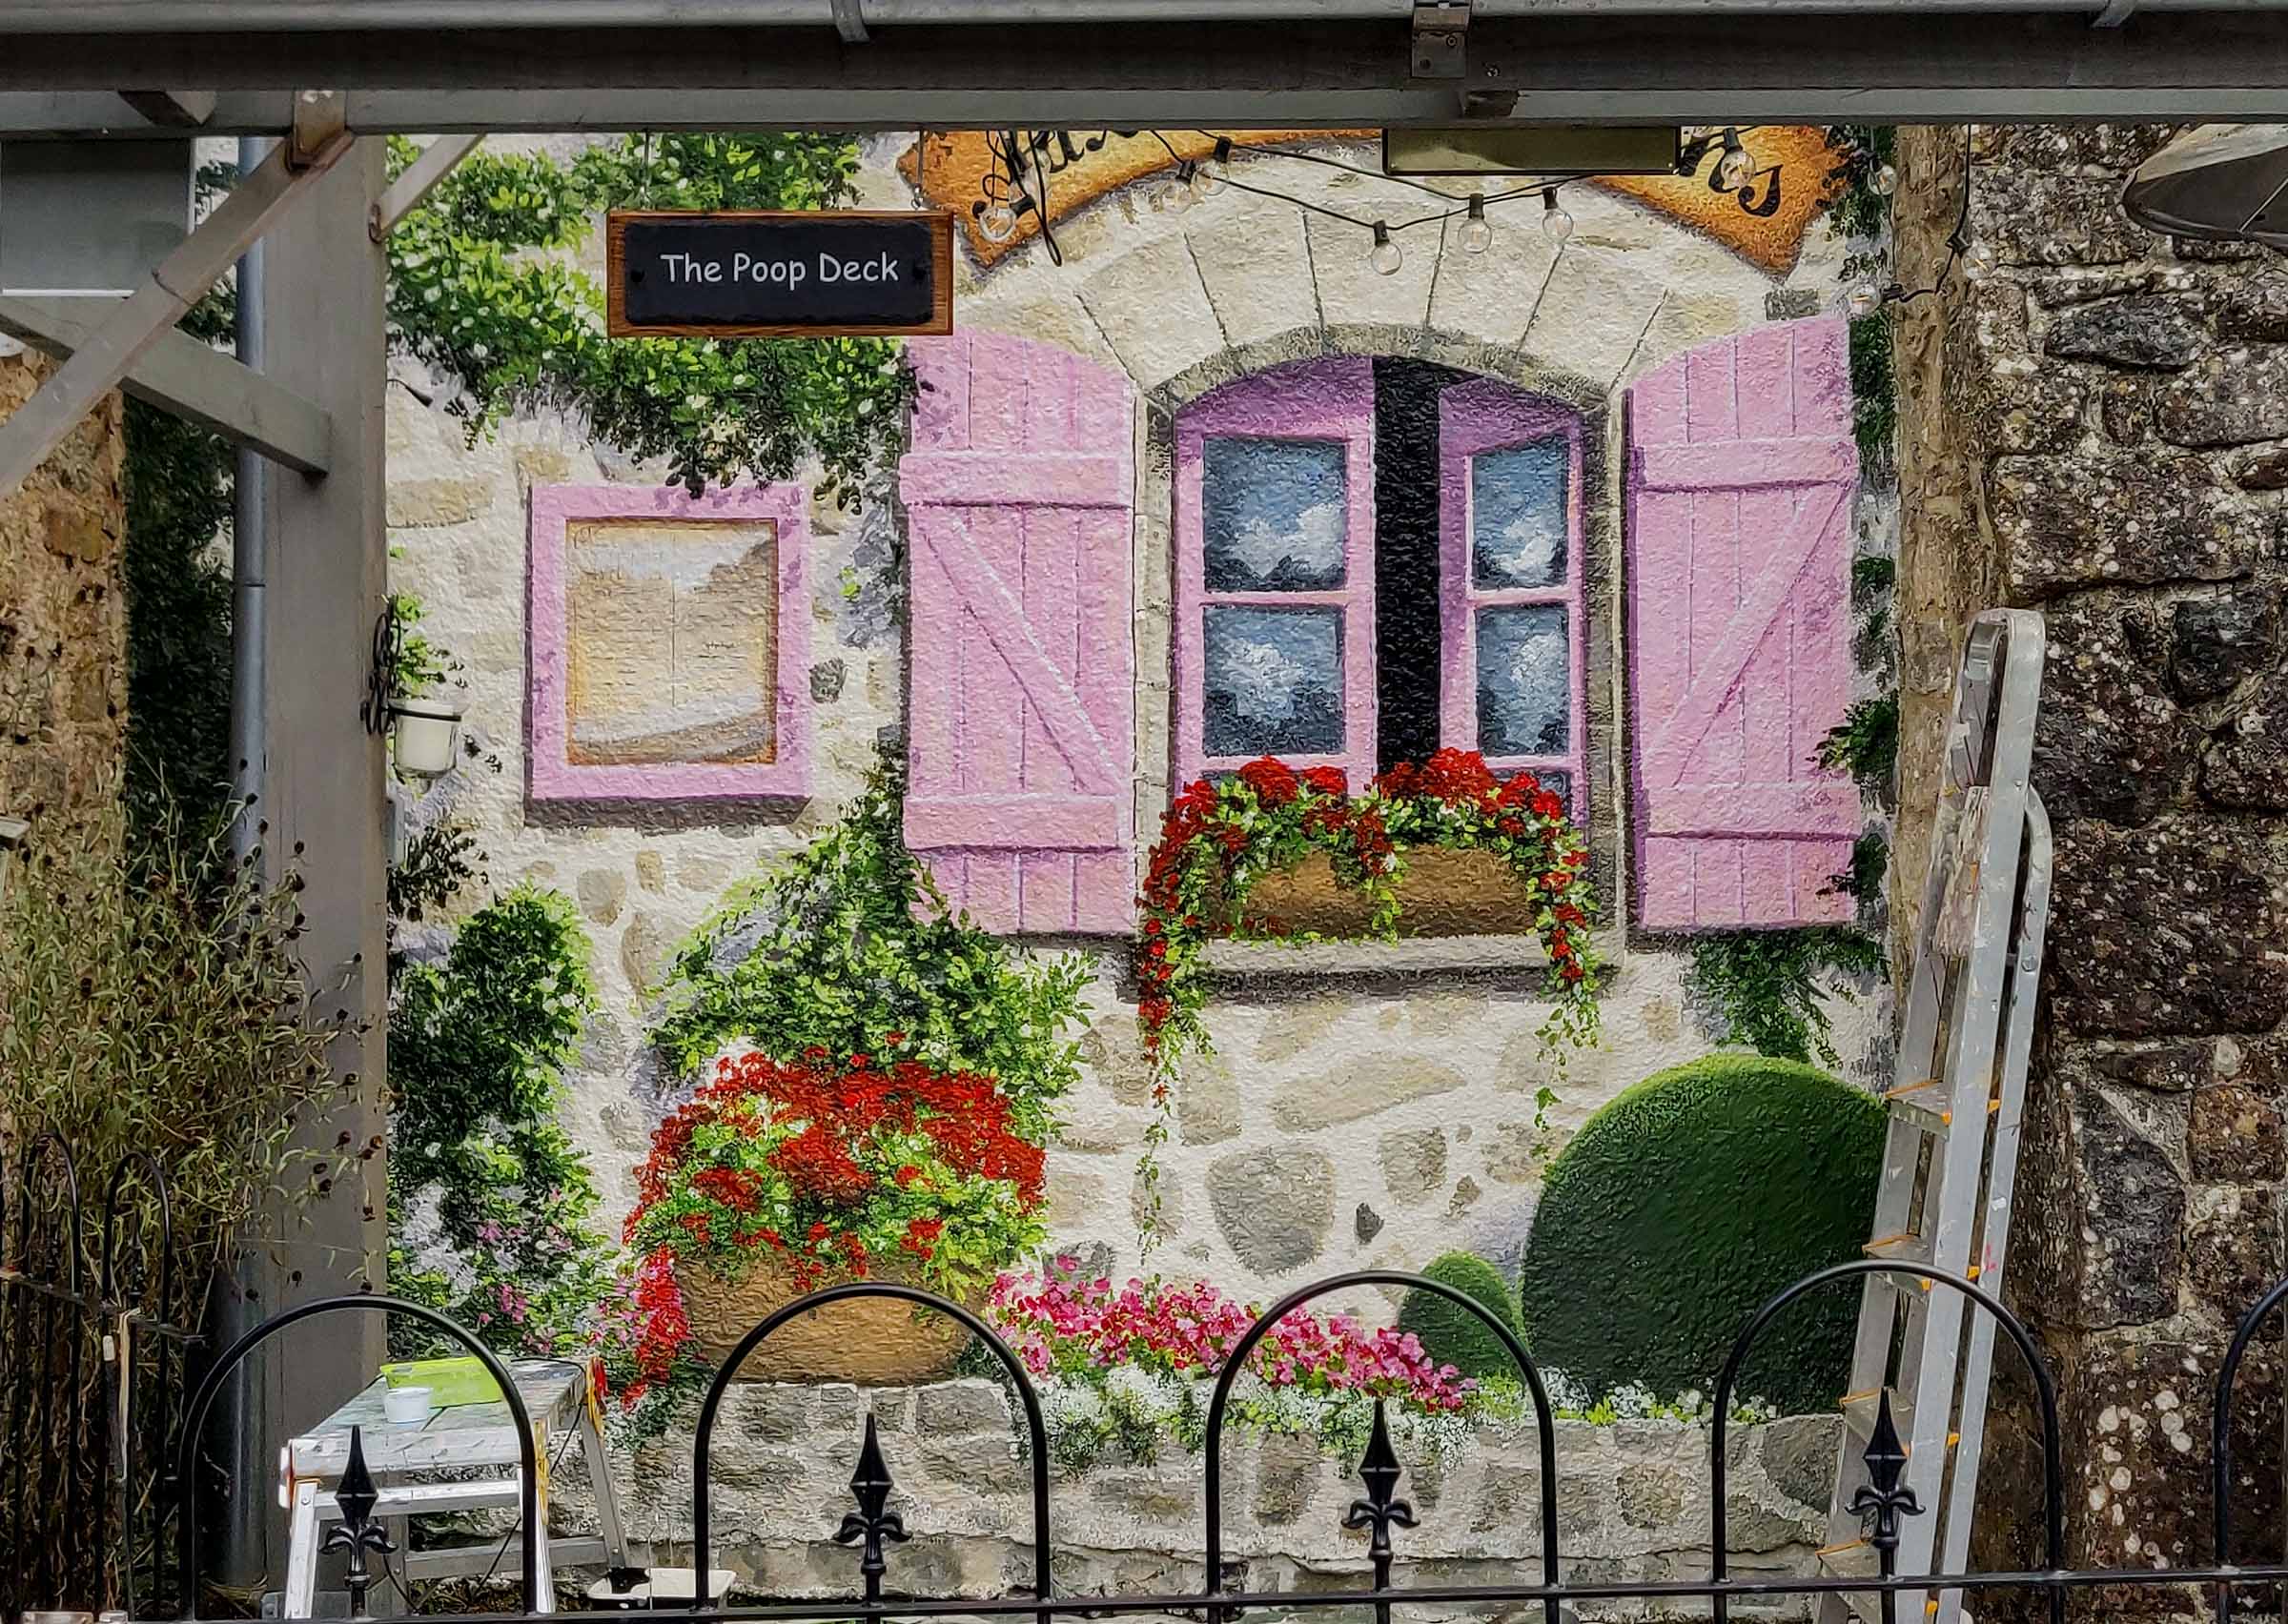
[0,353,128,848]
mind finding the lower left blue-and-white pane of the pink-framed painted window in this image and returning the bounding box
[1201,604,1343,755]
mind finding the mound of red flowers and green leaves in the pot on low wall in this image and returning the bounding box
[627,1050,1043,1297]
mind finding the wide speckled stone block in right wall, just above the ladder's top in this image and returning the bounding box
[1989,451,2272,601]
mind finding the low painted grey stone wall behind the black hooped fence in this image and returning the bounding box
[556,1379,1842,1617]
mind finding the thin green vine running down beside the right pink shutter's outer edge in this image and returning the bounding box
[1688,124,1899,1066]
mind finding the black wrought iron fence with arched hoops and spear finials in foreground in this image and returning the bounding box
[166,1260,2288,1624]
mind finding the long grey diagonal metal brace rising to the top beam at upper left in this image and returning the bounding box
[0,135,353,497]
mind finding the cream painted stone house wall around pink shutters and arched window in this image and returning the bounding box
[389,139,1886,1292]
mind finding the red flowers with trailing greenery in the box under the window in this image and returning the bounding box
[1134,750,1600,1248]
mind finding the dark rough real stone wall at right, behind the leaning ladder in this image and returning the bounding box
[1899,126,2288,1611]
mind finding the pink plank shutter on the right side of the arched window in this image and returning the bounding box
[1626,318,1860,931]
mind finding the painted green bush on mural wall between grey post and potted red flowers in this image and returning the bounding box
[389,883,616,1354]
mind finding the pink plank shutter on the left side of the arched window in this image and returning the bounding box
[899,334,1134,933]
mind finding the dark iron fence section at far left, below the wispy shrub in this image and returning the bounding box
[0,1134,206,1617]
